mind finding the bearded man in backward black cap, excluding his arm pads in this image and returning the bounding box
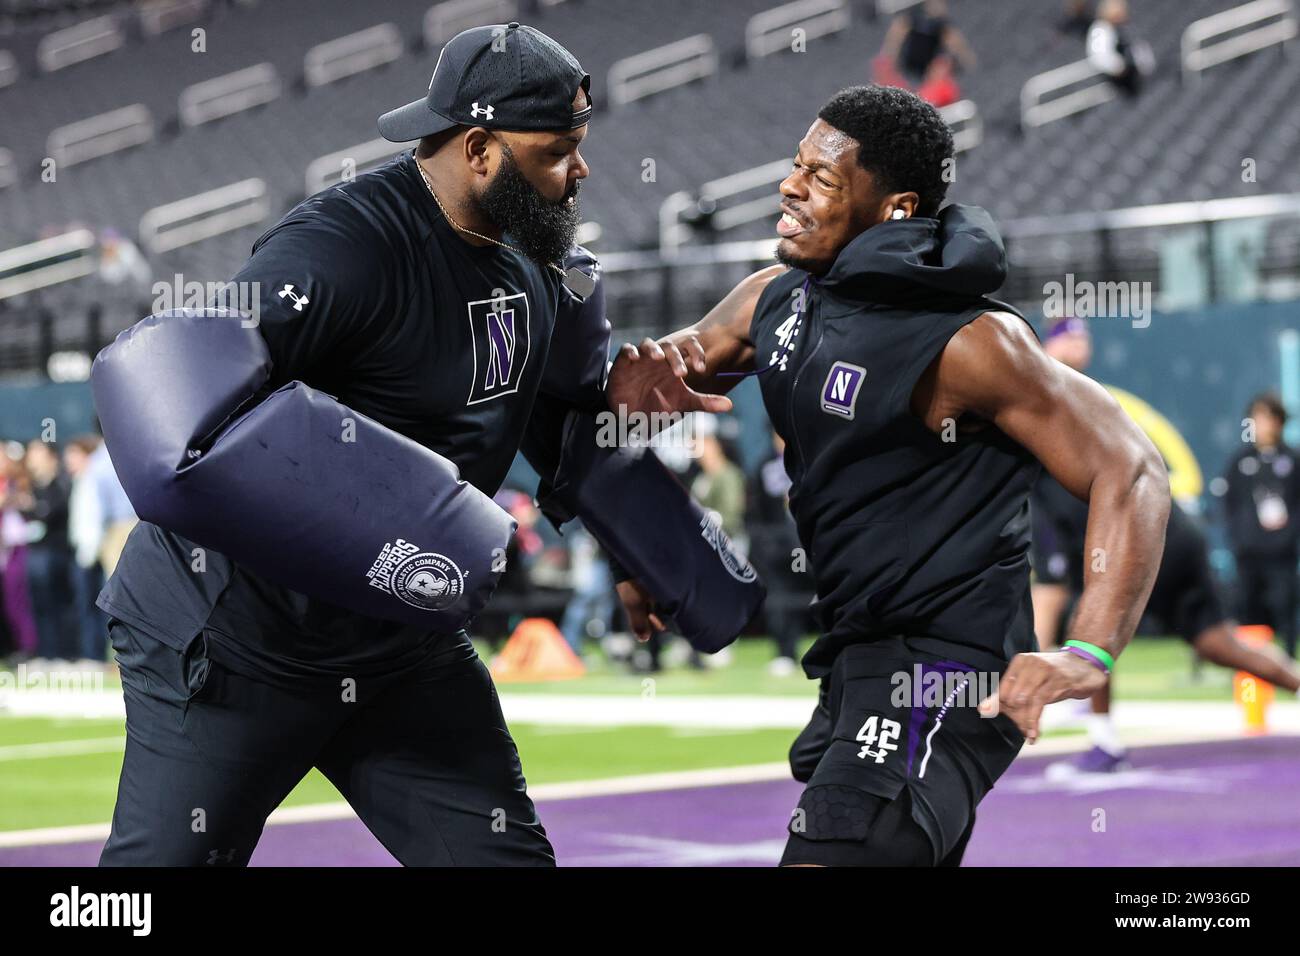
[99,23,607,865]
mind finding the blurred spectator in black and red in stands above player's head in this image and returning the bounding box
[874,0,975,107]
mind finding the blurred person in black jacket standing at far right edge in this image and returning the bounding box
[1223,394,1300,657]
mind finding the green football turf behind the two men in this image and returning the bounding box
[0,639,1231,830]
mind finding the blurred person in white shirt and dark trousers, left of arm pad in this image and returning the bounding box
[64,436,108,663]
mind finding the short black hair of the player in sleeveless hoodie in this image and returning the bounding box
[818,86,953,216]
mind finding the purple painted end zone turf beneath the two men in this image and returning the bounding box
[0,737,1300,866]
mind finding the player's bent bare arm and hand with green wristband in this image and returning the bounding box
[913,312,1170,743]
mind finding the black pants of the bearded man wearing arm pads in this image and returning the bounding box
[100,619,555,866]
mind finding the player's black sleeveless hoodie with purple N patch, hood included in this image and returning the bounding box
[751,206,1039,676]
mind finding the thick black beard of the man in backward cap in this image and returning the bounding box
[477,146,582,265]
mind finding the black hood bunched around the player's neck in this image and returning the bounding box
[815,203,1006,303]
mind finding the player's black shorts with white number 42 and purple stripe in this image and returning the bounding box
[781,637,1024,866]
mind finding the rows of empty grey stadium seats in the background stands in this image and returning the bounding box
[0,0,1300,365]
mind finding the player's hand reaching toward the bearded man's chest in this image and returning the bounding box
[605,332,732,424]
